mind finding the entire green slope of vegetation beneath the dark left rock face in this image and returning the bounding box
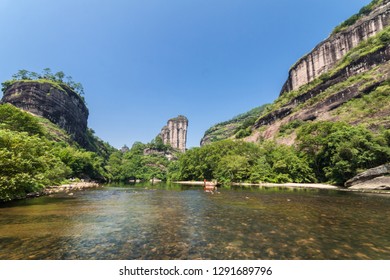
[0,104,109,201]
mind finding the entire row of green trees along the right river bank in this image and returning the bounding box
[177,121,390,185]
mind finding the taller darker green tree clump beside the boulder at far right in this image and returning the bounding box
[298,122,390,185]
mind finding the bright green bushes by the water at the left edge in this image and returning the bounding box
[0,129,70,201]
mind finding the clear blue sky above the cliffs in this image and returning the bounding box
[0,0,370,148]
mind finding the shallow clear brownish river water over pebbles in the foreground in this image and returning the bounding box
[0,184,390,259]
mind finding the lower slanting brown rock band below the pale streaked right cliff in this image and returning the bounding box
[254,45,390,129]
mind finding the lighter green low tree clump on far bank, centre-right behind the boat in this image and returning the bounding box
[178,140,315,182]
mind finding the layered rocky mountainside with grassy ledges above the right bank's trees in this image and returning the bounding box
[202,0,390,144]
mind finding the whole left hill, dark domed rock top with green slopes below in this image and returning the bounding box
[0,70,115,203]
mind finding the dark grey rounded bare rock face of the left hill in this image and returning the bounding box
[1,81,89,147]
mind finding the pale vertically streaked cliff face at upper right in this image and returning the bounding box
[281,0,390,94]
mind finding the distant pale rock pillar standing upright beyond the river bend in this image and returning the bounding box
[160,116,188,152]
